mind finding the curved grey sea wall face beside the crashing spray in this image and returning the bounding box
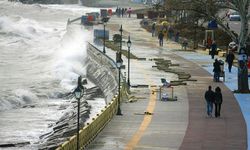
[87,44,118,104]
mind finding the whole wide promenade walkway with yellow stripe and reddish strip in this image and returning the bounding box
[88,14,247,150]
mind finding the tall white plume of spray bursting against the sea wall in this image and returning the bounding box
[54,25,87,90]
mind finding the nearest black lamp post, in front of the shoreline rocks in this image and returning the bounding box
[74,76,84,150]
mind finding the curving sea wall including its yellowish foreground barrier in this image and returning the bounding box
[57,44,127,150]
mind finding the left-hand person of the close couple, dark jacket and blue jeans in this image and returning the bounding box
[205,86,214,117]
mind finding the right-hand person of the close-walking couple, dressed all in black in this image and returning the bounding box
[214,87,223,117]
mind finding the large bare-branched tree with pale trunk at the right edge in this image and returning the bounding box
[165,0,250,93]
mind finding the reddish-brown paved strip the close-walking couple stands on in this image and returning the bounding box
[172,54,247,150]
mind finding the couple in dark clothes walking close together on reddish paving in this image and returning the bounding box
[205,86,223,117]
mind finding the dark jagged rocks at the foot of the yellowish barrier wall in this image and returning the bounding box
[39,87,103,150]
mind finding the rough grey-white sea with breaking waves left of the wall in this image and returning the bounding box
[0,0,103,149]
